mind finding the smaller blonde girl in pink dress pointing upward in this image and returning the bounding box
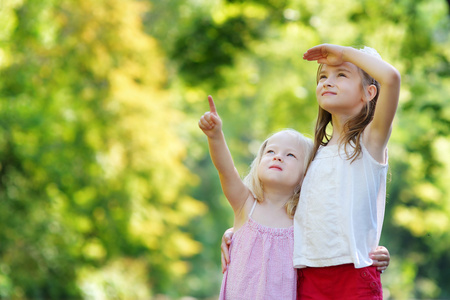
[199,96,313,300]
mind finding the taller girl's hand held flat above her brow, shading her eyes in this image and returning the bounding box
[303,44,345,66]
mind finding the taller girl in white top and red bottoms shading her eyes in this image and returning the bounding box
[294,44,400,300]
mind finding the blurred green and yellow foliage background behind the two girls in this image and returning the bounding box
[0,0,450,299]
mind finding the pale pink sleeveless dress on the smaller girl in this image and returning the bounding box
[219,201,297,300]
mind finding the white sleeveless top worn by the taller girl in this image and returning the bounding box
[293,143,388,268]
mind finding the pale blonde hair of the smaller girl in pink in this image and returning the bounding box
[243,129,313,218]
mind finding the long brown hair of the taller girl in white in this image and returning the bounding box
[306,64,380,169]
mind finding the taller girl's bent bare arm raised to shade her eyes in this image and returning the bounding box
[303,44,400,151]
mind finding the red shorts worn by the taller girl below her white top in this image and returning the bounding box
[297,264,383,300]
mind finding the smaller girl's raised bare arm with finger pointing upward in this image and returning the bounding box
[198,96,249,212]
